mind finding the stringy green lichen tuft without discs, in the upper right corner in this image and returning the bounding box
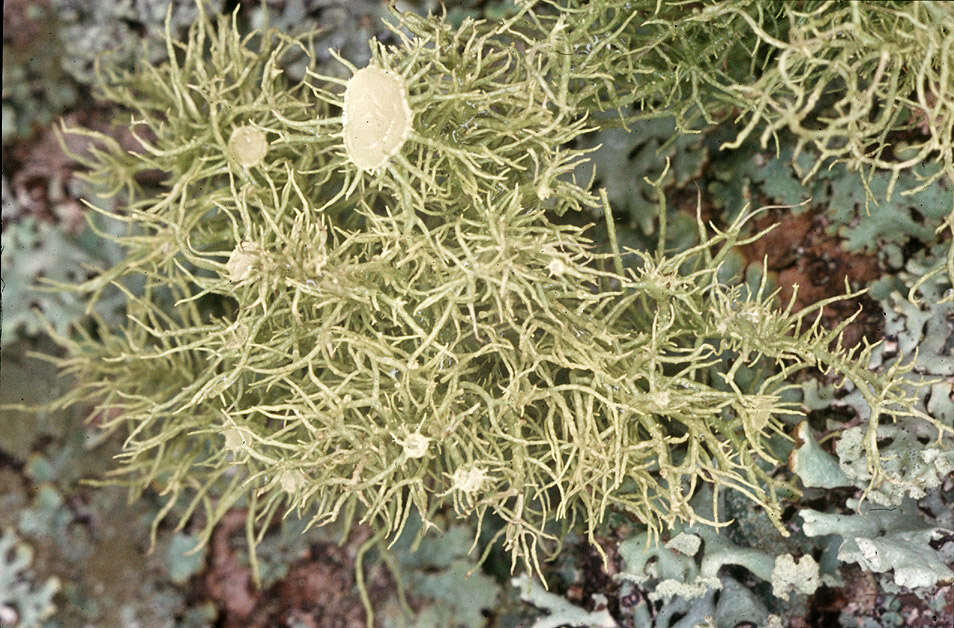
[572,0,954,199]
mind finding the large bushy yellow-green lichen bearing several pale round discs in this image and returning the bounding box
[42,2,944,592]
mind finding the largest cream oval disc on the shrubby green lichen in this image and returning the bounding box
[343,65,411,170]
